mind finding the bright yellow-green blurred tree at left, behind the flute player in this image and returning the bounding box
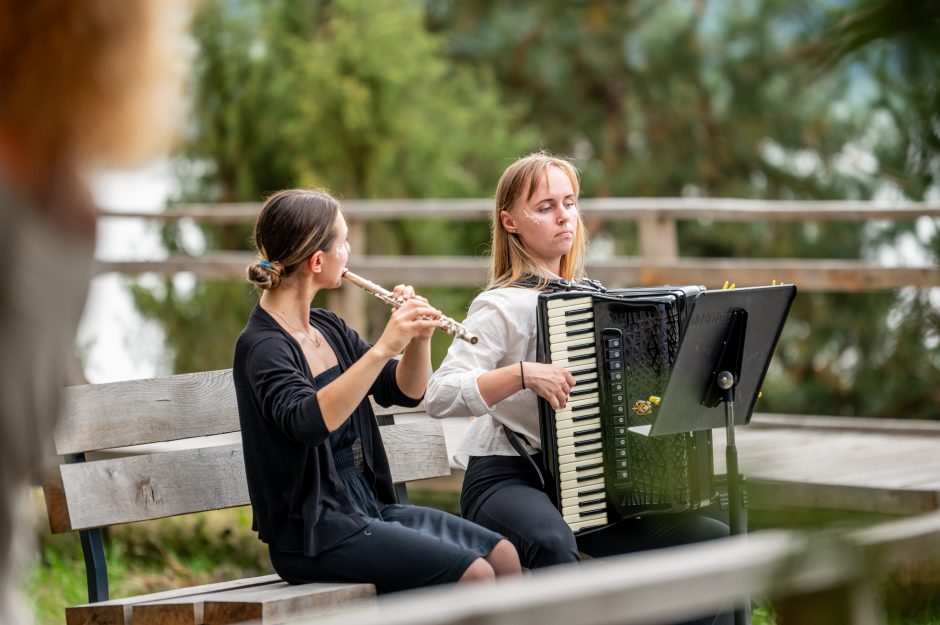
[134,0,532,372]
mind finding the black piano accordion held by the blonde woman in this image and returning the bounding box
[537,286,717,532]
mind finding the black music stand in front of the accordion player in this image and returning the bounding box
[649,285,796,625]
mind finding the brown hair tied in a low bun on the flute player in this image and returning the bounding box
[247,189,340,290]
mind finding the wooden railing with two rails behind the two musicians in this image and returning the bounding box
[98,198,940,332]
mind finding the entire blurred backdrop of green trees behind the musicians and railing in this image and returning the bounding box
[135,0,940,418]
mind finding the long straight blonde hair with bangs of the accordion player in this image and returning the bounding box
[488,151,587,288]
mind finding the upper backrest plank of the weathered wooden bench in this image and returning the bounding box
[55,369,423,455]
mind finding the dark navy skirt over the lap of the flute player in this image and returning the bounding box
[271,505,502,593]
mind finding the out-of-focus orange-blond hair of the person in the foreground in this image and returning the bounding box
[0,0,189,166]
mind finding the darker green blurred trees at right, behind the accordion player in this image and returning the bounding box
[427,0,940,417]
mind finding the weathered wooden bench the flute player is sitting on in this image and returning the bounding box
[43,370,450,625]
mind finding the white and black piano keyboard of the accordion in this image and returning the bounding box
[548,297,607,532]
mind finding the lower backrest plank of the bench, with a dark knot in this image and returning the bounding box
[43,418,450,533]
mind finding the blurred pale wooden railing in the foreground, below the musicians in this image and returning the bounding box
[297,513,940,625]
